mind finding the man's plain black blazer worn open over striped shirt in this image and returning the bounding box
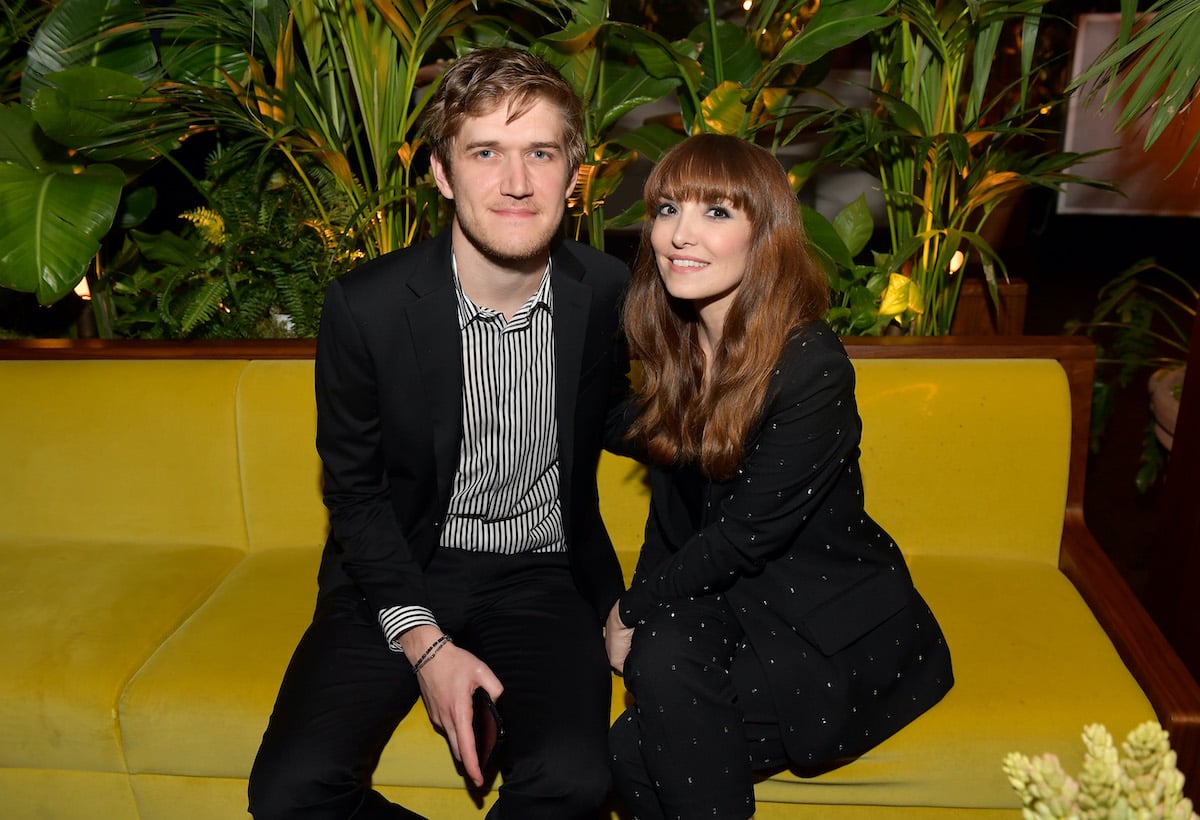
[316,232,629,621]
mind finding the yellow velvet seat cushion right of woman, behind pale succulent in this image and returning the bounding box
[756,556,1154,808]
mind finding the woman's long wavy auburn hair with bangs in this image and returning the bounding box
[624,133,829,480]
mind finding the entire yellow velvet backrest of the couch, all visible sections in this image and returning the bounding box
[0,348,1072,564]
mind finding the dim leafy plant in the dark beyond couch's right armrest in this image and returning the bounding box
[1067,259,1200,492]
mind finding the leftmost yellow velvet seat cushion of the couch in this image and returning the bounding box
[0,539,244,772]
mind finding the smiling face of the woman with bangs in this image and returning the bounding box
[650,195,752,329]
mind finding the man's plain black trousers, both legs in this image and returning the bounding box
[250,549,612,820]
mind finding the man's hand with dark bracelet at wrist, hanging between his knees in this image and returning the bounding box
[400,627,504,786]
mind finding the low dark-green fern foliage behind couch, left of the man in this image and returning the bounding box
[94,151,358,339]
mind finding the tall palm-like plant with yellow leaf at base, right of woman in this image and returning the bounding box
[822,0,1111,335]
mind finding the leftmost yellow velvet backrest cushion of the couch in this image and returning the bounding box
[0,360,253,549]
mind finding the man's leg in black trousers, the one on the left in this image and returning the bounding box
[250,593,420,820]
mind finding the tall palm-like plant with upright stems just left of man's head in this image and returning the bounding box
[176,0,476,257]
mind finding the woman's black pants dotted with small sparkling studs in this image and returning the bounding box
[608,595,787,820]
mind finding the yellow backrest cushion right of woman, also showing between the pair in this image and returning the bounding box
[600,359,1072,565]
